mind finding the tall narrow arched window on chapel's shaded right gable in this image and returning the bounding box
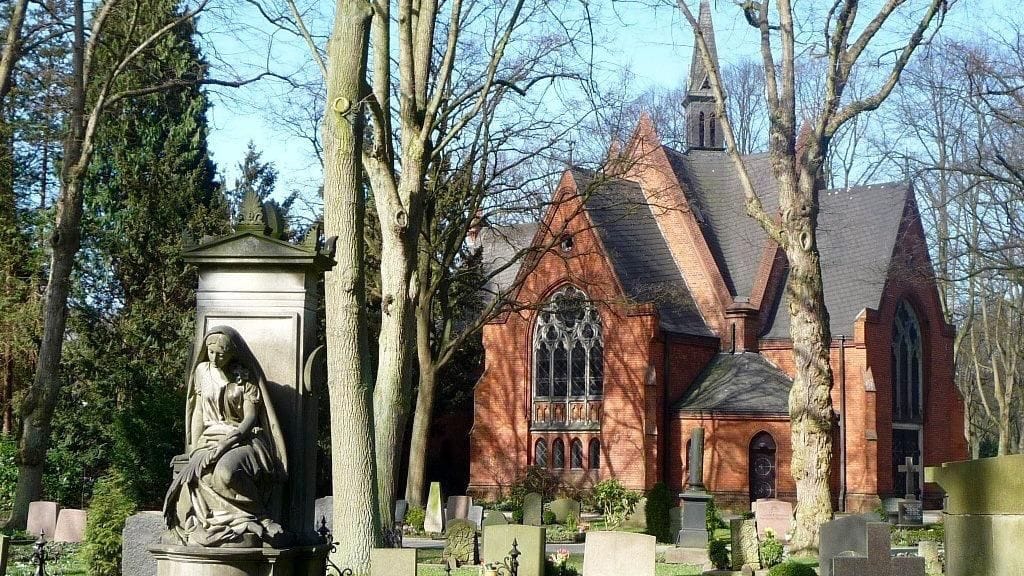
[892,301,924,422]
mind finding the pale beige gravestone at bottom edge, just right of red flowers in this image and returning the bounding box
[583,531,656,576]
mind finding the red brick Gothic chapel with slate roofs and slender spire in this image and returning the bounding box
[469,2,968,510]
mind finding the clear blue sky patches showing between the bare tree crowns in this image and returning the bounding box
[201,0,1016,204]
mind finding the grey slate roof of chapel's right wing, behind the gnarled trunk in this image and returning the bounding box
[763,182,909,338]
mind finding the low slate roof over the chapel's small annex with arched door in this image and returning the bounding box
[673,353,793,415]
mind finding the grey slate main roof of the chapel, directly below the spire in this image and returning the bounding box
[666,148,778,296]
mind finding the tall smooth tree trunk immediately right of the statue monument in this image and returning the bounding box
[324,0,380,574]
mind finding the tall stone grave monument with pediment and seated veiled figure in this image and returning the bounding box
[150,193,334,576]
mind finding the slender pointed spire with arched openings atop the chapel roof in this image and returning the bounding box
[683,0,725,150]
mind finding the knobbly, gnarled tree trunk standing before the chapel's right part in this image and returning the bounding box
[779,179,835,554]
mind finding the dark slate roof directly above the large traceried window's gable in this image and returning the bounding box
[572,169,714,336]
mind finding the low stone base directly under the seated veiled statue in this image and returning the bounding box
[148,544,331,576]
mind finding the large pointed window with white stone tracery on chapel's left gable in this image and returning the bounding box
[534,286,604,400]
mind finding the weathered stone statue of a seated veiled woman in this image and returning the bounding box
[164,327,288,546]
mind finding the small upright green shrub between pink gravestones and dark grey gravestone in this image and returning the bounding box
[83,471,136,576]
